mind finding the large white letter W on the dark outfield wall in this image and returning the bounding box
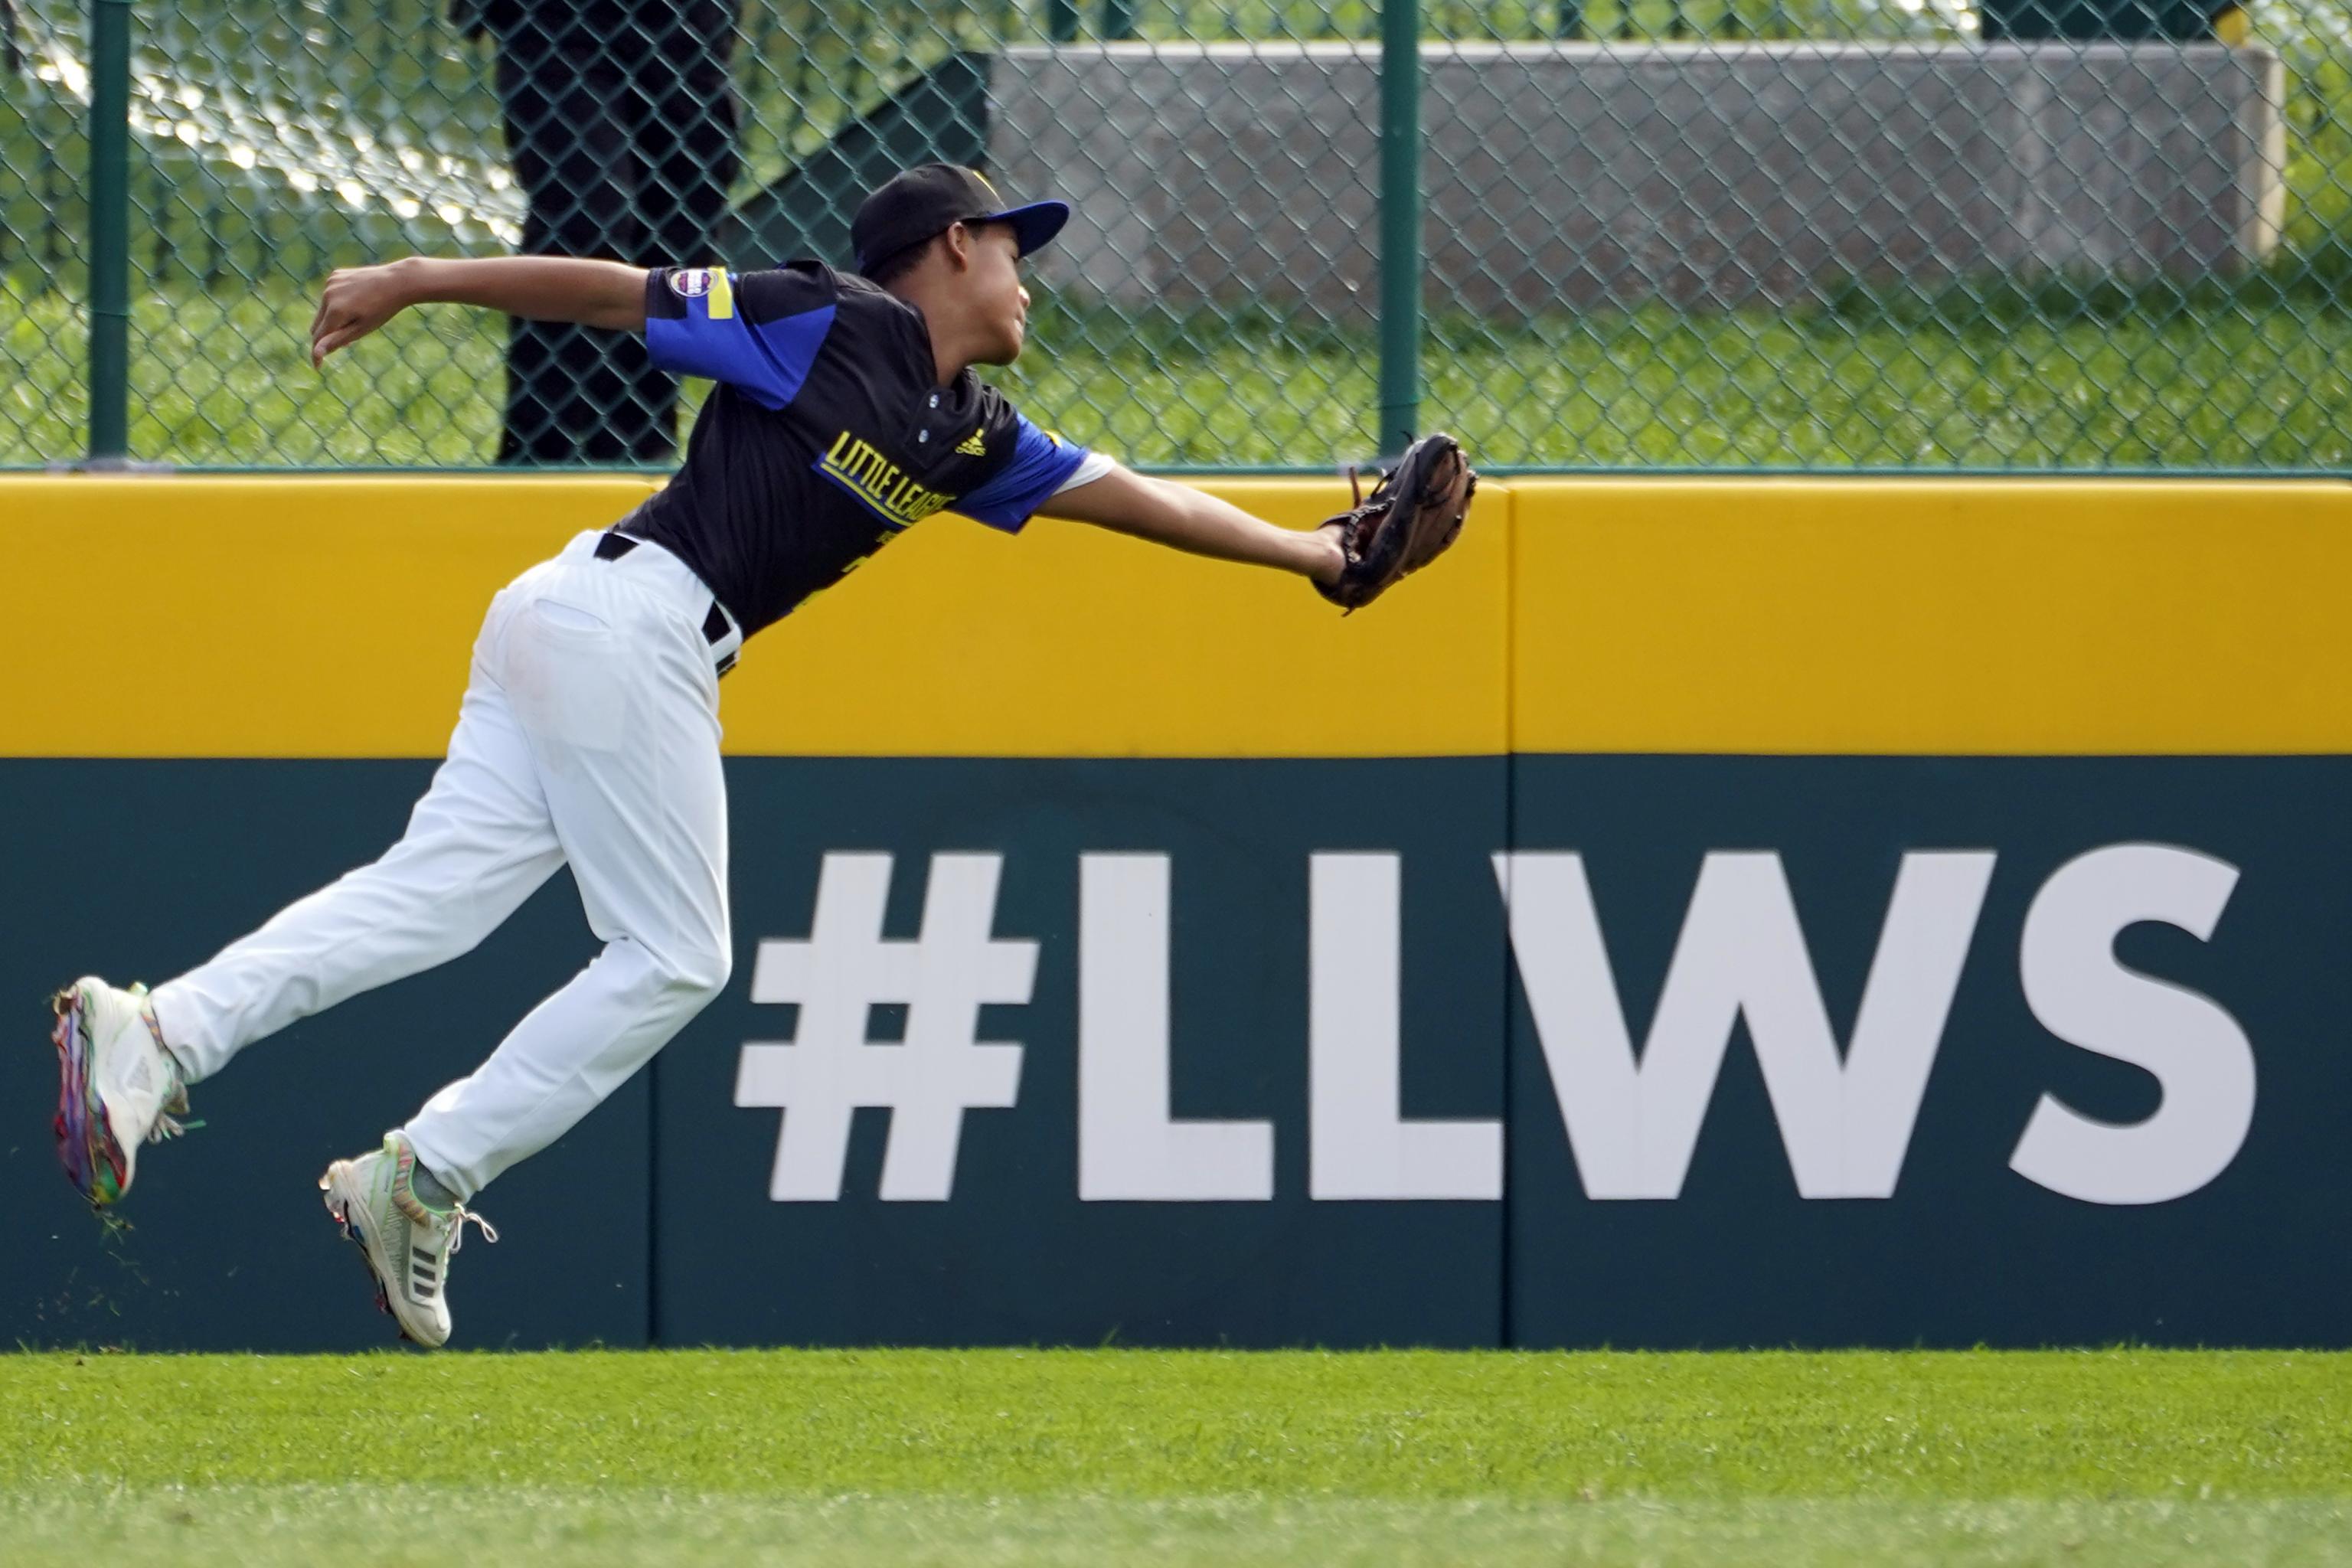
[1494,851,1992,1199]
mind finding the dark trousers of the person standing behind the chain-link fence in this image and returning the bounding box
[496,11,737,463]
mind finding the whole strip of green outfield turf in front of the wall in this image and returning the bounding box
[0,1352,2352,1568]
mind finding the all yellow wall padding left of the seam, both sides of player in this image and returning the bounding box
[0,475,1510,757]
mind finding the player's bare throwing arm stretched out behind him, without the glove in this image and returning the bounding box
[311,256,645,367]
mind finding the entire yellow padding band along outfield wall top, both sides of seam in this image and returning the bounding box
[0,475,2352,757]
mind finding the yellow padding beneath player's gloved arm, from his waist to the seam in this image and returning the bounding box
[724,479,1510,757]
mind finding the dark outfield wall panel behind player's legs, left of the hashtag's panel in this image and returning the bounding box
[0,760,649,1349]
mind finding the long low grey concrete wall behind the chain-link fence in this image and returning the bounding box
[988,44,2284,315]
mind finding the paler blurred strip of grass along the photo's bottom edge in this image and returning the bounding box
[14,1486,2352,1568]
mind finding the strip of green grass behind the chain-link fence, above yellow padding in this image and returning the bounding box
[14,277,2352,470]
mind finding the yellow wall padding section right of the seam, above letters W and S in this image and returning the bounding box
[1512,479,2352,755]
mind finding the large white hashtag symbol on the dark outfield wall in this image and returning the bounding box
[737,854,1037,1204]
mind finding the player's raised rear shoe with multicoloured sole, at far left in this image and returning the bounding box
[50,975,200,1208]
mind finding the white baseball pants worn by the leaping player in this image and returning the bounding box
[153,534,741,1197]
